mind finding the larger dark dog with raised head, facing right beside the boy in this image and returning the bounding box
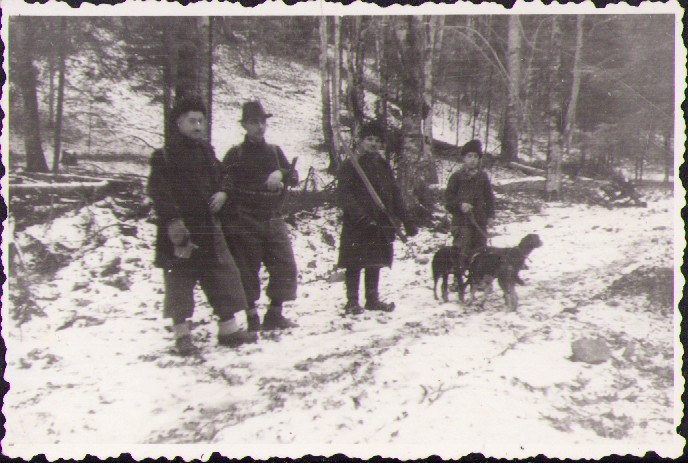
[467,234,542,310]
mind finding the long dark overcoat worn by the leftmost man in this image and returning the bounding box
[148,132,228,268]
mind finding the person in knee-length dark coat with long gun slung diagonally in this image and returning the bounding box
[337,122,418,315]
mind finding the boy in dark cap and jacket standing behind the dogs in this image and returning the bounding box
[445,140,494,266]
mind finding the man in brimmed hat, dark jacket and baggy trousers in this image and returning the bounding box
[222,101,299,331]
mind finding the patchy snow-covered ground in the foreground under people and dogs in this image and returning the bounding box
[2,167,683,459]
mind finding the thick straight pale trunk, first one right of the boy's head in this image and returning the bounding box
[500,15,521,162]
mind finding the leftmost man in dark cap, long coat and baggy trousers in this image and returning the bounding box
[148,98,257,355]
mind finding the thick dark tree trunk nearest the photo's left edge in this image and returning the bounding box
[12,16,48,172]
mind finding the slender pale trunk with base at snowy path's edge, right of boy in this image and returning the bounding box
[545,16,563,201]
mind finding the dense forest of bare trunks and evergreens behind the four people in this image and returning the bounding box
[9,15,674,212]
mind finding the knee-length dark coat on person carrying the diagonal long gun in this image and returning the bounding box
[337,153,406,268]
